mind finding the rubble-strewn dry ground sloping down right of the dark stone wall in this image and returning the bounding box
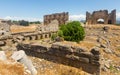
[85,25,120,75]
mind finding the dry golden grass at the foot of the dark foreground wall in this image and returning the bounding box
[29,57,89,75]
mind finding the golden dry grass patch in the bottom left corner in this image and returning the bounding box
[0,61,25,75]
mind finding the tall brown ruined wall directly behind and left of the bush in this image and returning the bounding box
[44,12,69,25]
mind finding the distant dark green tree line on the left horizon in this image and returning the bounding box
[6,20,41,26]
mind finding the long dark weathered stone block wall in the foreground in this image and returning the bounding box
[17,42,100,75]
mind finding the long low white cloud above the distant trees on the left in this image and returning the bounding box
[3,16,42,21]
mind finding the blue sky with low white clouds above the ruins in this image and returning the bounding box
[0,0,120,20]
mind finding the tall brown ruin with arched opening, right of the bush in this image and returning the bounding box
[86,10,116,25]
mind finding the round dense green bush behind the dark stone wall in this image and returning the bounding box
[60,21,85,42]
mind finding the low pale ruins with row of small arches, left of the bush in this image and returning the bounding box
[0,20,59,46]
